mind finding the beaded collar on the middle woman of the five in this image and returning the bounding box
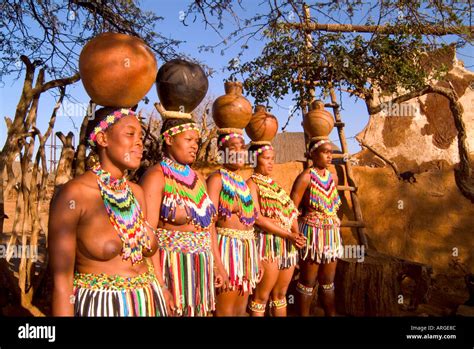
[219,168,257,226]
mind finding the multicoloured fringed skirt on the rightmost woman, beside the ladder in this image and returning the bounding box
[299,211,344,263]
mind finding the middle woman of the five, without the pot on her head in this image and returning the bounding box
[207,129,263,316]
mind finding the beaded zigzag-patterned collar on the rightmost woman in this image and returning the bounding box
[309,168,341,216]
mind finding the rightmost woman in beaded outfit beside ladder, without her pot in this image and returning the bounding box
[291,137,343,316]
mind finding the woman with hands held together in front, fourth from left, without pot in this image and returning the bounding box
[247,142,306,316]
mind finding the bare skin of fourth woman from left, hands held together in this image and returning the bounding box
[247,150,306,317]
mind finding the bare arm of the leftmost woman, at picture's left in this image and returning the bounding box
[48,182,81,316]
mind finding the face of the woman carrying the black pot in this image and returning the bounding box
[165,130,199,165]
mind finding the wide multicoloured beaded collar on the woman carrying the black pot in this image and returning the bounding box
[160,157,216,229]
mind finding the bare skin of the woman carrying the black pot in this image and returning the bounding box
[140,130,226,316]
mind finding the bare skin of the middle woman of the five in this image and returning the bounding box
[207,138,263,316]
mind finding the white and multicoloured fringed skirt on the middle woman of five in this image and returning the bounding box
[216,227,259,293]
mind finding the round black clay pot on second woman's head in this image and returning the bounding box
[156,59,209,113]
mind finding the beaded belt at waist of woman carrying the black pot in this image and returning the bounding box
[156,228,211,253]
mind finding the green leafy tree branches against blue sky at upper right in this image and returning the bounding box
[191,0,472,104]
